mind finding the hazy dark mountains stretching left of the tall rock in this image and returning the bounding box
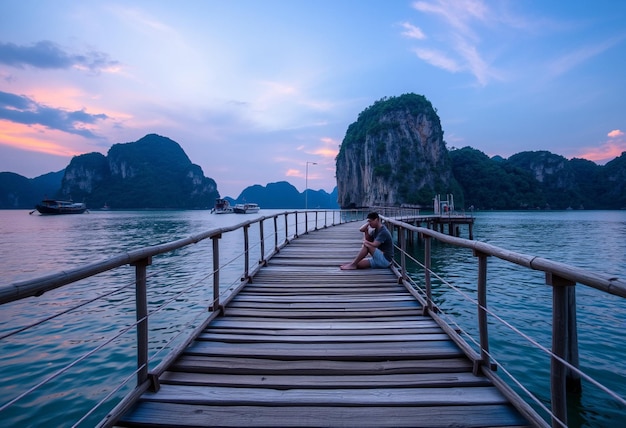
[0,134,338,209]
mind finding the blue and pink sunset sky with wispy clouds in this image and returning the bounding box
[0,0,626,197]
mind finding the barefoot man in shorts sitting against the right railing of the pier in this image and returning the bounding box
[340,212,393,270]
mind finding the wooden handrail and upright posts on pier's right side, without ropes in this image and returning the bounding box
[385,218,626,427]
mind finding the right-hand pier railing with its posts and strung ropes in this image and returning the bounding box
[385,217,626,427]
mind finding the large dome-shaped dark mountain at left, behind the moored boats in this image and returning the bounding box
[60,134,219,208]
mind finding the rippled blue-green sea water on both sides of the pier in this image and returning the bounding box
[0,210,626,427]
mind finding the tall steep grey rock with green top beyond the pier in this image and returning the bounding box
[337,94,462,207]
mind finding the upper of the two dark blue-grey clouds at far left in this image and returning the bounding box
[0,40,119,73]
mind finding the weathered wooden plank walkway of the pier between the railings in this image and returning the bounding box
[117,223,530,427]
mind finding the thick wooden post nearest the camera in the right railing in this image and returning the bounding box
[546,272,578,427]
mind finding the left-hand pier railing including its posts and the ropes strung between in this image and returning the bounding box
[0,210,366,426]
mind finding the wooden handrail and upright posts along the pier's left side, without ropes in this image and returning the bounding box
[0,210,367,425]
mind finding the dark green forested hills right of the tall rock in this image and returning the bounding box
[450,147,626,210]
